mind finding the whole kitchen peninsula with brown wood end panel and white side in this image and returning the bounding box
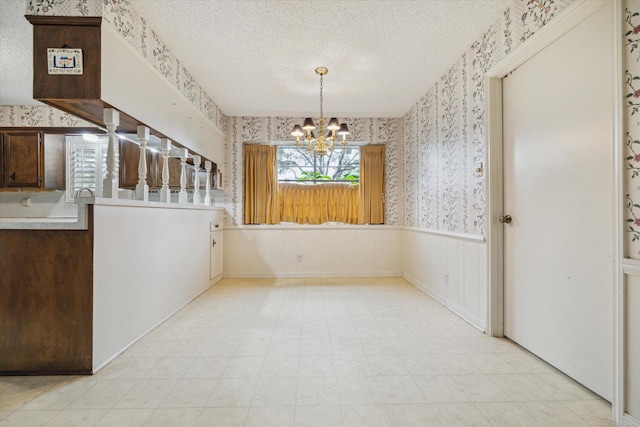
[0,197,223,375]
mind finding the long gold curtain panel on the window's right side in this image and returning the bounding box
[358,145,384,224]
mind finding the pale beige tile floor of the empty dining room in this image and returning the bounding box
[0,278,613,427]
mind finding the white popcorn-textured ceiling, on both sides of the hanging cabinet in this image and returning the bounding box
[0,0,511,117]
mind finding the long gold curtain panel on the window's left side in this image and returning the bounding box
[244,144,280,224]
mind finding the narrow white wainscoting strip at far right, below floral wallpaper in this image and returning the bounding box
[621,259,640,427]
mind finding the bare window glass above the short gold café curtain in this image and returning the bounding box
[277,145,360,184]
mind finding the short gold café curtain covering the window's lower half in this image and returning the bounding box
[278,183,359,224]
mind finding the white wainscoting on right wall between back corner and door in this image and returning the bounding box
[402,227,487,331]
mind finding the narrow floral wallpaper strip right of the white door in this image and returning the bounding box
[621,0,640,259]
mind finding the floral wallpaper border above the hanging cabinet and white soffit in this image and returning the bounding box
[26,0,226,132]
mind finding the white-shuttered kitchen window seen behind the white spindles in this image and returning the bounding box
[66,135,119,201]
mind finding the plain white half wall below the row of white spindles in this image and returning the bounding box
[93,205,220,371]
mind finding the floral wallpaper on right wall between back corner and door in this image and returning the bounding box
[402,0,576,236]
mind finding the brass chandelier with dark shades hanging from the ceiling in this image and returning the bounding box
[291,67,349,157]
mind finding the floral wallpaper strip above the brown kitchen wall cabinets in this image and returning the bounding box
[0,105,96,128]
